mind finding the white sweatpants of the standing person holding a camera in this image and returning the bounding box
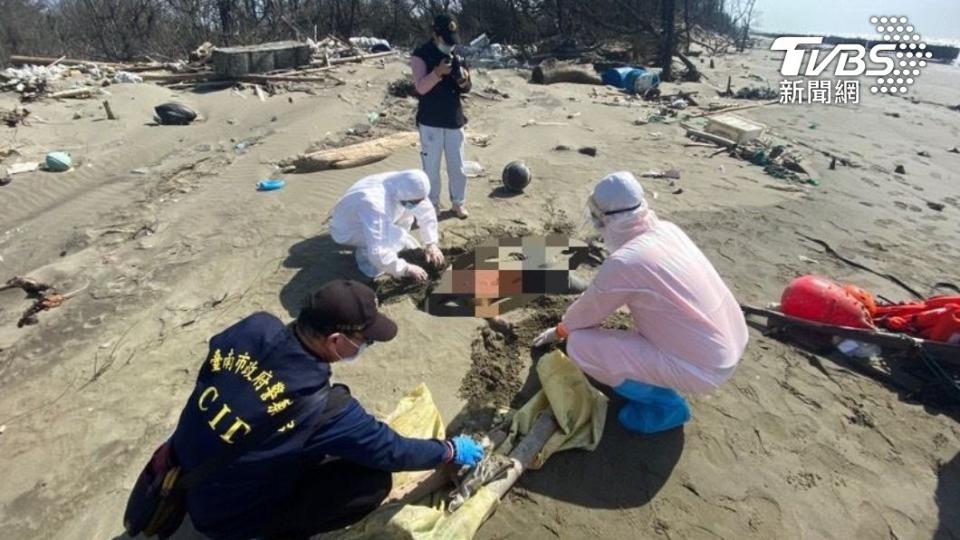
[420,124,467,209]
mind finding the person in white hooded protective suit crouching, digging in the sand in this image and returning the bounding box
[330,170,444,281]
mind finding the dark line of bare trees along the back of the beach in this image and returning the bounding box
[0,0,756,62]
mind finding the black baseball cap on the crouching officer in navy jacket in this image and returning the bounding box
[297,279,397,341]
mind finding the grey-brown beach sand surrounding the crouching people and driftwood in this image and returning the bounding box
[0,42,960,539]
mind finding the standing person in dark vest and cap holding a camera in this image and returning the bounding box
[410,14,471,219]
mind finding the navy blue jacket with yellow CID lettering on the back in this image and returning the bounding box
[173,313,447,539]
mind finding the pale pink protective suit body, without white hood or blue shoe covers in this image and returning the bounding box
[563,208,747,393]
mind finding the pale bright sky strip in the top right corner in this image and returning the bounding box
[756,0,960,41]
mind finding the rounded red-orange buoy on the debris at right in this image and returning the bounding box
[780,275,874,328]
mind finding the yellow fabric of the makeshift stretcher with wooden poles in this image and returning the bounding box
[322,351,607,540]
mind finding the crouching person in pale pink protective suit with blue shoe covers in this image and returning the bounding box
[533,172,747,433]
